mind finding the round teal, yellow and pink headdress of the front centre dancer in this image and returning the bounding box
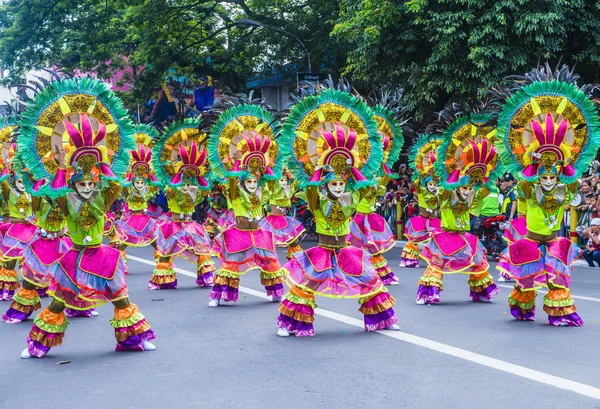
[281,90,383,188]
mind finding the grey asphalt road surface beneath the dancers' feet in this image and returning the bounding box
[0,242,600,409]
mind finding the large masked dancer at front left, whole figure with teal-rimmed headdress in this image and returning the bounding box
[18,78,155,358]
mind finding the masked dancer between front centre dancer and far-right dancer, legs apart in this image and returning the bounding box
[416,114,500,304]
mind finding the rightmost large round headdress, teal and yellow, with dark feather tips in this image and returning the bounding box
[493,64,600,183]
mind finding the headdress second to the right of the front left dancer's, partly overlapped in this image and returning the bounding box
[151,119,211,190]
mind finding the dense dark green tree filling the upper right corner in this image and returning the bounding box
[332,0,600,119]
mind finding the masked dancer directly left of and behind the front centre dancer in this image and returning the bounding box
[208,104,284,307]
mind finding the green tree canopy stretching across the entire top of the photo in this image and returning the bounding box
[0,0,600,127]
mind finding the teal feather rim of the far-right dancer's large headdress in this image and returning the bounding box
[496,80,600,184]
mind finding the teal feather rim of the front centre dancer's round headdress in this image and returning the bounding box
[279,89,383,187]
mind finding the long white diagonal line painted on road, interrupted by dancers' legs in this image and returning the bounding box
[127,255,600,399]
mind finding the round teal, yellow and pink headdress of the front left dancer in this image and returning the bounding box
[17,78,135,197]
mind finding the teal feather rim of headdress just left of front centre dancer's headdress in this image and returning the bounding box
[208,104,278,178]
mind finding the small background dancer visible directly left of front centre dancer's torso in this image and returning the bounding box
[258,169,305,259]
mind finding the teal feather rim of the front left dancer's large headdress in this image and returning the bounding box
[17,78,135,198]
